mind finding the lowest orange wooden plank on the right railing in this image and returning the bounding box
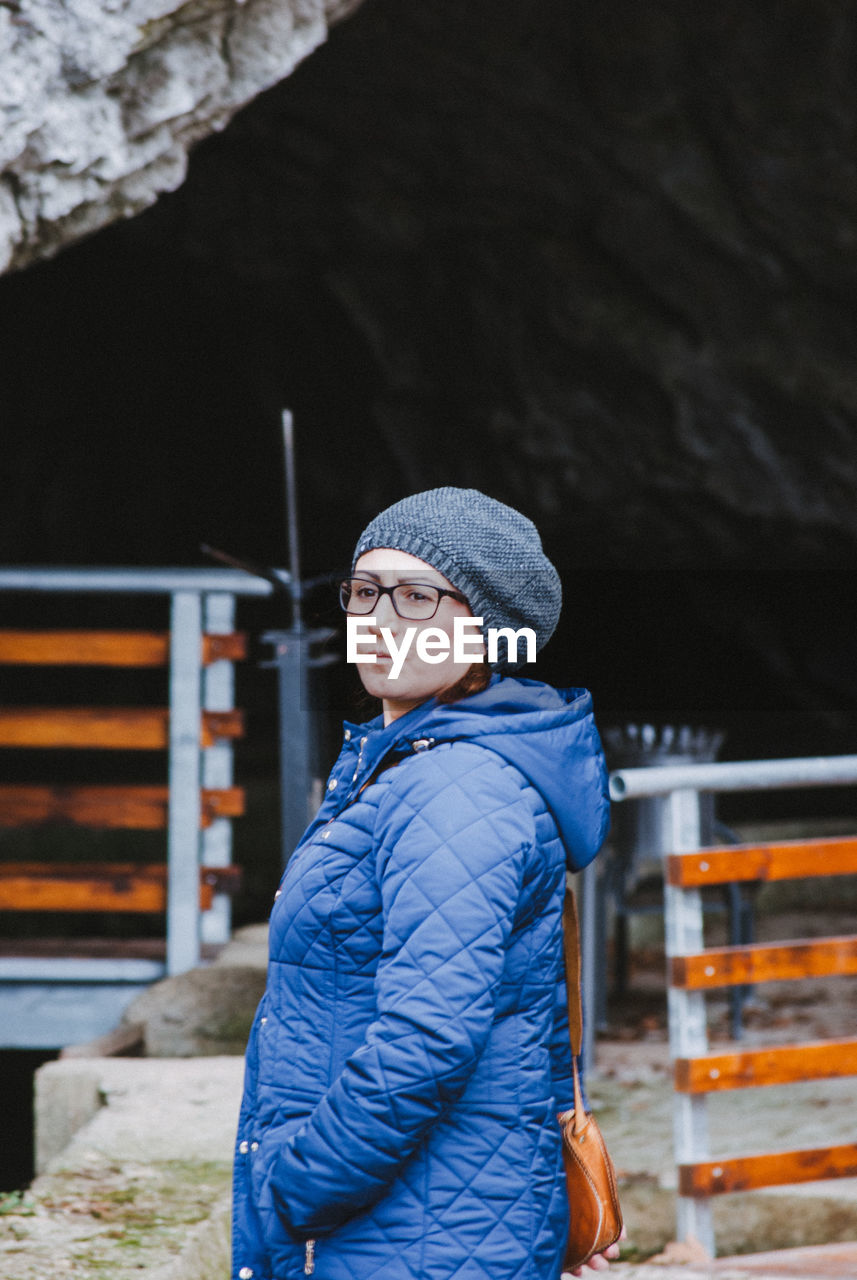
[678,1142,857,1197]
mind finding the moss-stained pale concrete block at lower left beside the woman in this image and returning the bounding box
[0,1057,244,1280]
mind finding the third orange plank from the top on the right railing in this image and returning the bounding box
[673,1039,857,1093]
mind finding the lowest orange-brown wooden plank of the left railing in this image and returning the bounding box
[0,863,240,914]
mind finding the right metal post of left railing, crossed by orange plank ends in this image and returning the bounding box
[200,591,235,942]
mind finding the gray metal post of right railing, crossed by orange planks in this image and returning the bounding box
[664,790,714,1257]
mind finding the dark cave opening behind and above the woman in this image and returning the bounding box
[0,0,857,844]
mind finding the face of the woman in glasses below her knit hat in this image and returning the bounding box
[354,547,480,724]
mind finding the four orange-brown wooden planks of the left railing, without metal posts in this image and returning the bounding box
[0,630,247,931]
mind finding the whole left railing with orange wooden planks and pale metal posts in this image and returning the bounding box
[0,570,278,1047]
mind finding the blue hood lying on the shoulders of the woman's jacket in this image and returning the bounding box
[347,675,610,870]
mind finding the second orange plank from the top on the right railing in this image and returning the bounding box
[670,934,857,991]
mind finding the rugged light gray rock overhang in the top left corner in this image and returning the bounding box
[0,0,359,271]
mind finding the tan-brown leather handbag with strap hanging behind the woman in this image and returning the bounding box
[558,890,622,1271]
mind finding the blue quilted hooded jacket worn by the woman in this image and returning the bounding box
[233,676,608,1280]
